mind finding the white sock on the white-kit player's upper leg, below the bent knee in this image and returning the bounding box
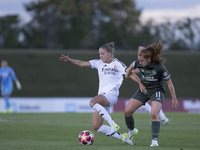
[93,103,116,126]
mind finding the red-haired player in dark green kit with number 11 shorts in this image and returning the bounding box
[124,40,179,146]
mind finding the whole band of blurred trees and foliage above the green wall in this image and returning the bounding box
[0,0,200,51]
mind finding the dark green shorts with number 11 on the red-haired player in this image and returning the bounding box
[131,89,165,105]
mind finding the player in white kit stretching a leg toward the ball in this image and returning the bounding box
[60,42,144,145]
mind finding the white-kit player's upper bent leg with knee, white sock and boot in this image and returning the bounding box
[90,94,119,134]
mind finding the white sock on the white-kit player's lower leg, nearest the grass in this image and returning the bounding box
[97,125,123,140]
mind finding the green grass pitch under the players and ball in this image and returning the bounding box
[0,112,200,150]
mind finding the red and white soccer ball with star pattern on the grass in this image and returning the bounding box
[78,130,94,145]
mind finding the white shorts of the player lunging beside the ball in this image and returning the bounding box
[102,93,118,113]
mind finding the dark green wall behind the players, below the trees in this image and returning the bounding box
[0,50,200,98]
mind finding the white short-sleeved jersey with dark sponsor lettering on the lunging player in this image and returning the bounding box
[89,59,127,96]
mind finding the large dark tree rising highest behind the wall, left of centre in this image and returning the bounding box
[23,0,140,49]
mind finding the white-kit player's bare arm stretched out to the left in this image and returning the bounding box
[60,54,91,67]
